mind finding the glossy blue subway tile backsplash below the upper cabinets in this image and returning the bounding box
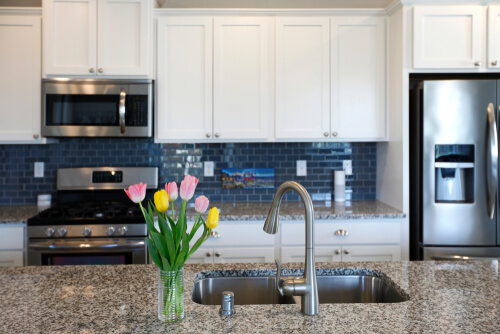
[0,138,376,205]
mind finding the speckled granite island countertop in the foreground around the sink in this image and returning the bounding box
[0,261,500,334]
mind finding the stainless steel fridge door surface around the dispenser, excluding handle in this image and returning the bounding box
[422,80,497,246]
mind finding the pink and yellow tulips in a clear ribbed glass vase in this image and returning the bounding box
[124,175,219,321]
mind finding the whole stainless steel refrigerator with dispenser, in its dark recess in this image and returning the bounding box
[410,75,500,260]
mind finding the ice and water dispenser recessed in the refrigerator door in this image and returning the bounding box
[434,145,475,203]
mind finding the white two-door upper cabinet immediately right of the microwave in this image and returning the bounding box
[156,16,273,141]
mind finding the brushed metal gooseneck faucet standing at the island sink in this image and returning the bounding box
[264,181,319,315]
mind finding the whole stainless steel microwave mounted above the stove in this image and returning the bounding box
[42,78,153,137]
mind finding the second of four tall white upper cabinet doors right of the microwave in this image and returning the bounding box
[214,16,273,140]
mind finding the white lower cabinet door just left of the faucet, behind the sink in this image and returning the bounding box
[214,247,274,263]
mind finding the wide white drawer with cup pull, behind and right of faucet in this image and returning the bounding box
[281,221,401,245]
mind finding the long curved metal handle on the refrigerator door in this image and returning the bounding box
[486,103,500,219]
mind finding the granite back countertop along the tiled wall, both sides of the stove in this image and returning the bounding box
[0,200,405,224]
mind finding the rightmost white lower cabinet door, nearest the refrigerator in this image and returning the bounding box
[342,245,401,262]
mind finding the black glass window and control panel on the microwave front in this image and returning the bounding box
[45,94,148,126]
